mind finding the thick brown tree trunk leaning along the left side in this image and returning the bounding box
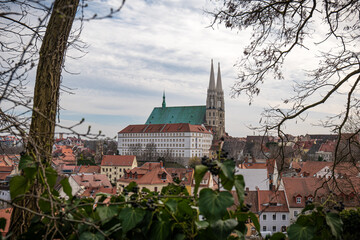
[9,0,79,236]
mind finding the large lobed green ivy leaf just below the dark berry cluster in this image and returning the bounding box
[199,188,234,220]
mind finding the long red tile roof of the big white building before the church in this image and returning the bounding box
[119,123,211,134]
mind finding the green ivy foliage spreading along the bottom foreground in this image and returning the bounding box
[9,153,354,240]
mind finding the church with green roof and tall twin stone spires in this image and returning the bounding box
[145,60,225,140]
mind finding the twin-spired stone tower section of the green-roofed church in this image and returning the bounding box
[206,60,225,139]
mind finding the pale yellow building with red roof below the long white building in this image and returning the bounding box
[101,155,137,184]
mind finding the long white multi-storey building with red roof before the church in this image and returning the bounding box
[118,123,213,164]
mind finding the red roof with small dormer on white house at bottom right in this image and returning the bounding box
[258,190,289,212]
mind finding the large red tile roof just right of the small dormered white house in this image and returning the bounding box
[282,177,329,208]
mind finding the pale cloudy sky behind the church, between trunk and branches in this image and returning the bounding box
[55,0,331,137]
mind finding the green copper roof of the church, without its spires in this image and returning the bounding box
[145,106,206,125]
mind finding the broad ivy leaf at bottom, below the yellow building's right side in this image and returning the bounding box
[119,207,145,233]
